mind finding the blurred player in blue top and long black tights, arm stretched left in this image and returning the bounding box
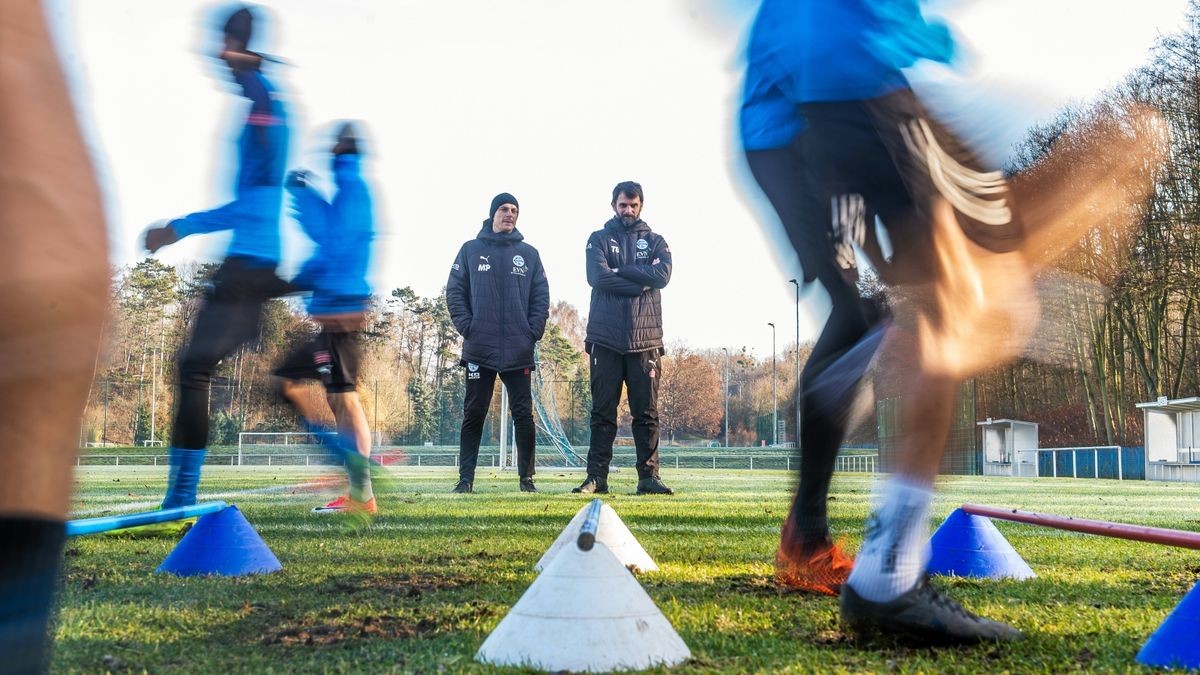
[145,7,288,508]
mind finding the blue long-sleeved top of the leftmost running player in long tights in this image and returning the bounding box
[170,71,288,267]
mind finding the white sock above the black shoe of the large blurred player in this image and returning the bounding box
[847,477,934,603]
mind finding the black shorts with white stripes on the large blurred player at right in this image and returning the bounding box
[802,89,1024,282]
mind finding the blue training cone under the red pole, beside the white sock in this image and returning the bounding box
[925,508,1037,579]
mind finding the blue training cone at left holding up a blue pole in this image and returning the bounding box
[156,506,283,577]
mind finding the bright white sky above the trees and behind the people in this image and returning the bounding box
[48,0,1186,356]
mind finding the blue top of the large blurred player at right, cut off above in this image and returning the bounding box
[739,0,954,150]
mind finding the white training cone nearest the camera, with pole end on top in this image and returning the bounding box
[475,535,691,673]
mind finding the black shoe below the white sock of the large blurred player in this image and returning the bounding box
[841,571,1024,645]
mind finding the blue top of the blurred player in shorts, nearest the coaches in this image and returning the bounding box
[288,155,376,316]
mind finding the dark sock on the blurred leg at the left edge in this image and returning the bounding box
[0,518,66,673]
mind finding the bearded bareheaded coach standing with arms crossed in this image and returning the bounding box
[572,181,672,495]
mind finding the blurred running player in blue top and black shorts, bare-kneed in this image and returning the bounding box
[275,123,378,514]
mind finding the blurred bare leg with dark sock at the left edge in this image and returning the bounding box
[0,0,109,673]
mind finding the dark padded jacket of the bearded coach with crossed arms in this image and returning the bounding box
[587,217,671,353]
